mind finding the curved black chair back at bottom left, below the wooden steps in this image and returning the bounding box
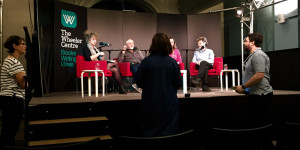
[3,138,110,150]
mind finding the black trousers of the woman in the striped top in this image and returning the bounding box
[0,96,24,149]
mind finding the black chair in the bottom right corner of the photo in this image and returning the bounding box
[276,122,300,150]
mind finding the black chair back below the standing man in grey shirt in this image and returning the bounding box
[205,124,274,150]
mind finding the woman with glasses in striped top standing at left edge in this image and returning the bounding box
[0,35,26,149]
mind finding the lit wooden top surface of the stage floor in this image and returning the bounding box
[29,87,300,106]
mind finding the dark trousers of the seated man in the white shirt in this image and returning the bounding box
[196,61,213,86]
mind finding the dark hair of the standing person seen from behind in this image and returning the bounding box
[149,33,172,55]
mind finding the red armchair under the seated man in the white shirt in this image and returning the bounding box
[190,57,223,83]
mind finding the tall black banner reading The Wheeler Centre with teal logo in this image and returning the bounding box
[53,2,87,91]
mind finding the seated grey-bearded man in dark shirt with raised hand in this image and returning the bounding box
[117,39,144,93]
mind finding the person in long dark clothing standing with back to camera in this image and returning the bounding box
[135,33,182,137]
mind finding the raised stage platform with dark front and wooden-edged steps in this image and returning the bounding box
[19,87,300,145]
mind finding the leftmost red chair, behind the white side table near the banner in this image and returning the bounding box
[76,55,112,92]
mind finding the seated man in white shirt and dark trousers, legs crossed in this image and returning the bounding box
[192,37,215,92]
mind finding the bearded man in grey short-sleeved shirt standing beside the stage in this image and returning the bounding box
[235,33,273,126]
